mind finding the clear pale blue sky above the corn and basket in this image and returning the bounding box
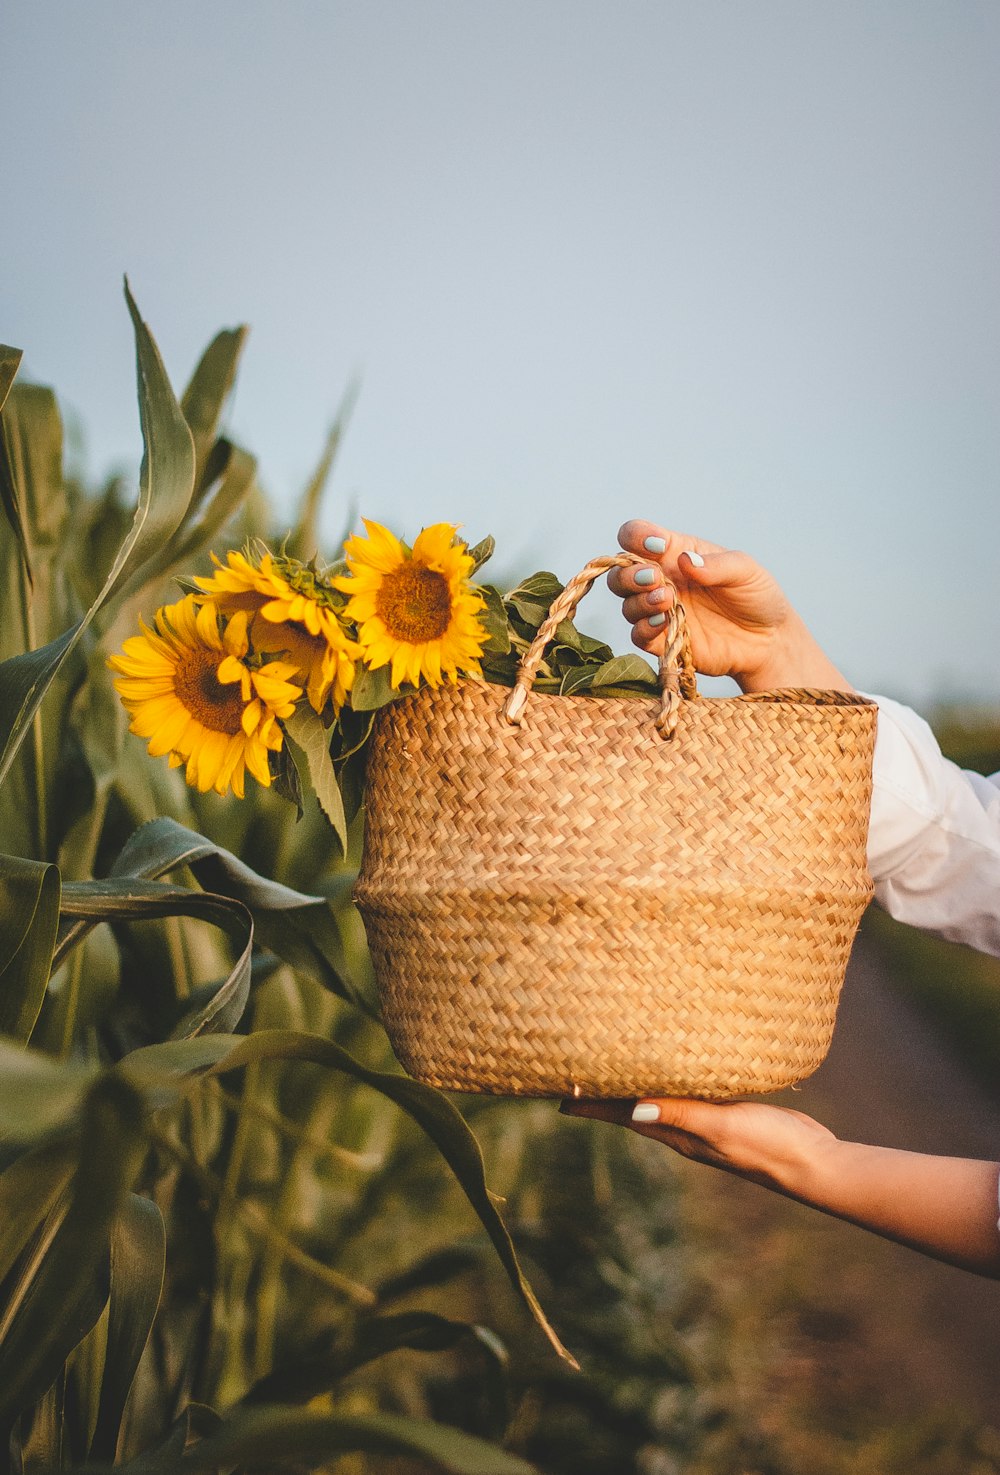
[0,0,1000,702]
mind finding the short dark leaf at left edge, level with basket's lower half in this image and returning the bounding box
[0,856,60,1043]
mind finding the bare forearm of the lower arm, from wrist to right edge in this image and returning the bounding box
[770,1137,1000,1279]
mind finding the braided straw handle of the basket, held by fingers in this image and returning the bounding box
[503,553,698,739]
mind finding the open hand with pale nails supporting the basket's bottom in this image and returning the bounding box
[560,1097,838,1196]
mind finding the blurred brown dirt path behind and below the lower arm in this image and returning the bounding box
[683,943,1000,1429]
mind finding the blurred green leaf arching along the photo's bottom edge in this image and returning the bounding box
[177,1406,537,1475]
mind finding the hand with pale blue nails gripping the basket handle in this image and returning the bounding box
[608,521,851,692]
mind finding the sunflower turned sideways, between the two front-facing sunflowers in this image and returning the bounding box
[195,552,361,712]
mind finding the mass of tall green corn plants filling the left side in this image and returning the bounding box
[0,289,569,1475]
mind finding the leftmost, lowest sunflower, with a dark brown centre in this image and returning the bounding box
[108,594,302,799]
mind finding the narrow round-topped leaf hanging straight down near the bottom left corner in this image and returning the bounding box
[90,1193,167,1460]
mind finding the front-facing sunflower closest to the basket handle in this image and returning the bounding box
[332,518,488,687]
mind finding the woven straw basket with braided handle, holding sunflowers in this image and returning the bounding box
[355,553,875,1099]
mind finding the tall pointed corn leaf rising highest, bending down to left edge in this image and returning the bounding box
[0,283,195,783]
